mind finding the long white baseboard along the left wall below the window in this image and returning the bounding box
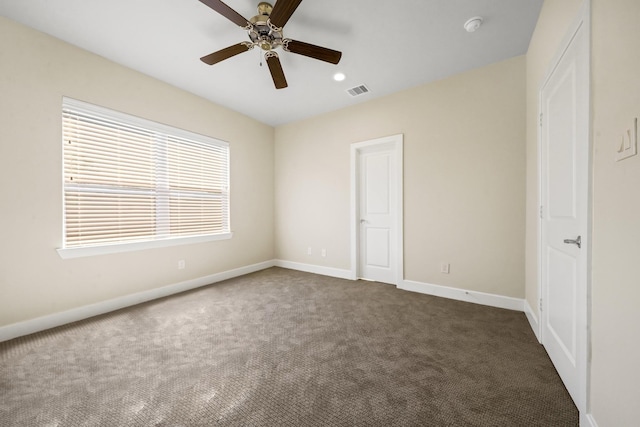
[0,261,275,342]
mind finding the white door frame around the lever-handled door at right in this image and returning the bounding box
[537,0,593,424]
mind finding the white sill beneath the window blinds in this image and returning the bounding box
[56,233,233,259]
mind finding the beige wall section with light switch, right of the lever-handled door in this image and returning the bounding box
[591,0,640,427]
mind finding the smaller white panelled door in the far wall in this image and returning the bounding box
[354,135,402,285]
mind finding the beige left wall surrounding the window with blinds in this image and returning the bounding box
[0,17,274,326]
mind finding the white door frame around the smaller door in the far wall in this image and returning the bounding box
[350,134,404,286]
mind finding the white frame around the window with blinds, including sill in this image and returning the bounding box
[56,97,233,259]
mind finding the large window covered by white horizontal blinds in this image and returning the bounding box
[61,98,230,257]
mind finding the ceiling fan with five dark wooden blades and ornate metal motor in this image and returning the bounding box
[200,0,342,89]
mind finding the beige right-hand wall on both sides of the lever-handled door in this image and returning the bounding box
[526,0,640,427]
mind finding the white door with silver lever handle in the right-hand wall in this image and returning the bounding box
[540,10,589,412]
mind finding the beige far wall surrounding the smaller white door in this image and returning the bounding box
[275,57,525,298]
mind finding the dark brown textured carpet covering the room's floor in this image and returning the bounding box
[0,268,578,427]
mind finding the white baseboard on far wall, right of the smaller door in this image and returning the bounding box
[398,280,524,311]
